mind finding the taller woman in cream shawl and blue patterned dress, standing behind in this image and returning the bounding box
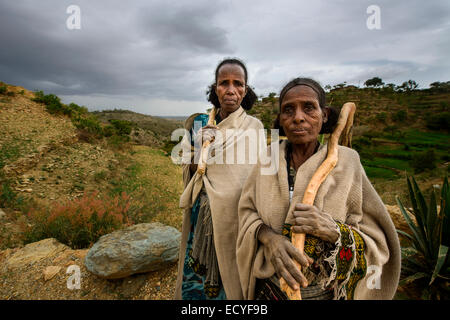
[175,59,263,300]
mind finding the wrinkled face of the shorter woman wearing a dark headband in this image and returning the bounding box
[280,85,327,144]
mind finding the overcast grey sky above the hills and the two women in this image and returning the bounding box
[0,0,450,115]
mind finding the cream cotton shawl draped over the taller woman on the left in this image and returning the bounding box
[175,107,264,299]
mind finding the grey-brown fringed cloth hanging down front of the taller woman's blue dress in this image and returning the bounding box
[192,191,220,286]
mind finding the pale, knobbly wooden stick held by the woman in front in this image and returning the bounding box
[280,102,356,300]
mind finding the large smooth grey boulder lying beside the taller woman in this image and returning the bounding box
[84,222,181,279]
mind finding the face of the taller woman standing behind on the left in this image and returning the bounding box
[215,64,247,114]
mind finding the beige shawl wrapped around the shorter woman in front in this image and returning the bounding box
[237,141,401,300]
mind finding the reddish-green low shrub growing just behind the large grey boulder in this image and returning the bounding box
[24,192,132,249]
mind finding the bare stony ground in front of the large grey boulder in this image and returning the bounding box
[0,239,177,300]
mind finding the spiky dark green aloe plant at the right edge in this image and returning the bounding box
[396,177,450,299]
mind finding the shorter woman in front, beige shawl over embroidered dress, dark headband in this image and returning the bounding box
[237,78,400,300]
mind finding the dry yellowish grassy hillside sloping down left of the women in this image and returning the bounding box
[0,83,182,249]
